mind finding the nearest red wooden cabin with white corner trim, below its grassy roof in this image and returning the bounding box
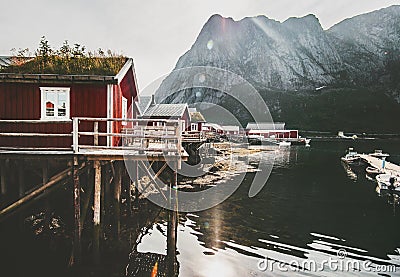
[0,58,138,148]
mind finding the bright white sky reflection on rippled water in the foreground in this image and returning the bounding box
[134,216,400,277]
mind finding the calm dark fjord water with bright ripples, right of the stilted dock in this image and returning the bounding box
[130,140,400,276]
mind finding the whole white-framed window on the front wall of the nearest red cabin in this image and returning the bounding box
[40,87,70,120]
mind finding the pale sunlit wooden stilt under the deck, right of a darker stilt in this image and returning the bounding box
[93,158,101,263]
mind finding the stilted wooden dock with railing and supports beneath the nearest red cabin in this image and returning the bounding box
[0,117,186,270]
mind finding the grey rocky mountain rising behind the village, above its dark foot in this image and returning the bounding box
[156,6,400,132]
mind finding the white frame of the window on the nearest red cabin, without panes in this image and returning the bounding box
[40,87,71,121]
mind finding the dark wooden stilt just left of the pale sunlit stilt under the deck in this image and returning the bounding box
[72,157,82,264]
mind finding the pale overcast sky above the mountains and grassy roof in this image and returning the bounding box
[0,0,400,89]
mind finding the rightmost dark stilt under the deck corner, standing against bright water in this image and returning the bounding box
[167,164,178,276]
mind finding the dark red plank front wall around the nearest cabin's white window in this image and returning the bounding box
[0,83,107,147]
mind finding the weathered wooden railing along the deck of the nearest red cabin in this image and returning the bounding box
[0,117,182,154]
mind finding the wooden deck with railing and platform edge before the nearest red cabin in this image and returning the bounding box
[0,118,188,161]
